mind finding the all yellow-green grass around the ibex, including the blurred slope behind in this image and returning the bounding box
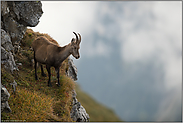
[1,29,119,122]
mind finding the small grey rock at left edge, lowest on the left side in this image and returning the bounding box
[1,84,11,113]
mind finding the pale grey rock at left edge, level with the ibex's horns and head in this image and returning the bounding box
[1,29,14,51]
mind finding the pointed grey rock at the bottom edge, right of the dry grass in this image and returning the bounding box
[70,90,90,122]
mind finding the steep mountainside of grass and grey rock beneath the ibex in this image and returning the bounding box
[1,1,119,122]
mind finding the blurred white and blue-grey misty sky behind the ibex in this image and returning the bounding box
[32,1,182,121]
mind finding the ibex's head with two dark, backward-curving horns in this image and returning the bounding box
[71,32,81,59]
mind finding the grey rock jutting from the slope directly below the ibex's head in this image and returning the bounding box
[66,58,77,81]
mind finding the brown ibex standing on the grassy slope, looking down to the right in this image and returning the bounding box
[32,32,81,86]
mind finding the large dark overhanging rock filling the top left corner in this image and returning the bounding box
[1,1,43,44]
